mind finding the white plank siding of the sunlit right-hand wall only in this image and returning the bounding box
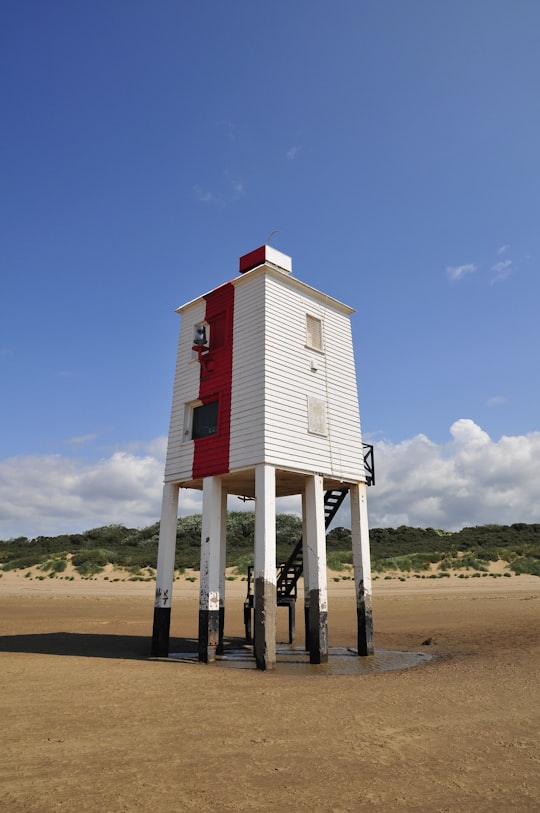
[265,275,364,480]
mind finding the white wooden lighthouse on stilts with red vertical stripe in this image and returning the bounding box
[152,246,373,669]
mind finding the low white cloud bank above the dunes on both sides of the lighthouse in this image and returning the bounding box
[0,418,540,540]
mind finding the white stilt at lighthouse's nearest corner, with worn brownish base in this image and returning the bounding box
[253,464,277,670]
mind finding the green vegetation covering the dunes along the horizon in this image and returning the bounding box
[0,511,540,580]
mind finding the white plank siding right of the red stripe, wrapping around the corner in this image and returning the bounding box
[231,270,364,481]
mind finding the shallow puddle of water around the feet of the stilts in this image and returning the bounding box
[169,646,433,675]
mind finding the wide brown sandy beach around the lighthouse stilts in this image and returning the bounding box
[0,573,540,813]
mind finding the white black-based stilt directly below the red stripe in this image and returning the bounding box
[199,477,223,663]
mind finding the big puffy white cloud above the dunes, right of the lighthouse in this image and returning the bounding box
[364,418,540,530]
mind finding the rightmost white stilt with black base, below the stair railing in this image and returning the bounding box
[350,483,374,655]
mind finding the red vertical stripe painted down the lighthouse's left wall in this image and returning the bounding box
[193,282,234,479]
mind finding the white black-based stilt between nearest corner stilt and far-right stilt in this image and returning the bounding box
[305,474,328,663]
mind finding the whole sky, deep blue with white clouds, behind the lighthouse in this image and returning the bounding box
[0,0,540,538]
